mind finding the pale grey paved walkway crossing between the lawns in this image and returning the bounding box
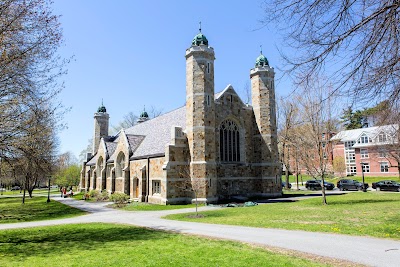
[0,197,400,267]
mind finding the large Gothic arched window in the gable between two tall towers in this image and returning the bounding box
[219,120,240,162]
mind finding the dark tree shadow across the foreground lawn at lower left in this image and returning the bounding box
[0,224,168,258]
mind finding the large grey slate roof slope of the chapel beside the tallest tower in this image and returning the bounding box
[125,106,186,158]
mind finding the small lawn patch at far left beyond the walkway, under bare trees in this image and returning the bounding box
[0,197,85,223]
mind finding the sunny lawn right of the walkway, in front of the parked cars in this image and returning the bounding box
[166,192,400,239]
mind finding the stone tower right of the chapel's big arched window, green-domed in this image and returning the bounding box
[250,52,279,178]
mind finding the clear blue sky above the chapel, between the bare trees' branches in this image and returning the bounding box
[53,0,291,160]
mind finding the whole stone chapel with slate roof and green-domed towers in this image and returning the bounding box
[80,31,282,205]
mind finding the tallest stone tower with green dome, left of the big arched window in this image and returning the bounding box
[186,29,217,202]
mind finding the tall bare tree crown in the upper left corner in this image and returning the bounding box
[0,0,67,168]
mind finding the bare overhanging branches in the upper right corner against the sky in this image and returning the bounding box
[264,0,400,106]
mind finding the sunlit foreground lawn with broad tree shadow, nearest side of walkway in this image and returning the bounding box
[0,224,328,267]
